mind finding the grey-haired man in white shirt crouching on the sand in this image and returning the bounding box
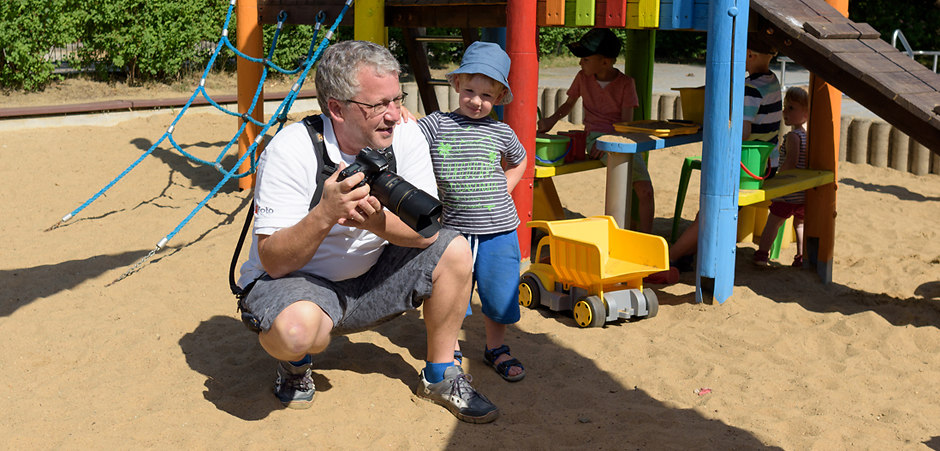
[239,41,499,423]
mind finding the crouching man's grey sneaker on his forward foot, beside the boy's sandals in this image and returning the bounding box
[415,365,499,423]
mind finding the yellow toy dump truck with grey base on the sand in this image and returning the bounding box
[519,216,669,327]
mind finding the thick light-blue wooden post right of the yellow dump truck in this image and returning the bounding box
[695,0,749,304]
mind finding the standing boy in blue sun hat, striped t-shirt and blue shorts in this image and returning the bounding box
[418,42,526,382]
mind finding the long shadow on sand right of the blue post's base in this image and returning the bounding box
[735,249,940,328]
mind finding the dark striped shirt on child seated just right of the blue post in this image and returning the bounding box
[744,72,783,168]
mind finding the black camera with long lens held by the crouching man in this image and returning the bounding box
[337,147,442,238]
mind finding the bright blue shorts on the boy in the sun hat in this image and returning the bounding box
[465,230,522,324]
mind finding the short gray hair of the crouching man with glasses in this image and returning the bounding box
[314,41,401,114]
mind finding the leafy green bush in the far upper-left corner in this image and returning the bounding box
[0,0,76,91]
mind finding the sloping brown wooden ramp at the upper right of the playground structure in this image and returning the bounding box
[751,0,940,155]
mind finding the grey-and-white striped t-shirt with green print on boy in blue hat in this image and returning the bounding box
[418,111,525,235]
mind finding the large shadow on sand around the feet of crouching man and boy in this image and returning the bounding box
[179,308,771,449]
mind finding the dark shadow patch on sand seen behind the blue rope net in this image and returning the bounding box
[131,138,250,193]
